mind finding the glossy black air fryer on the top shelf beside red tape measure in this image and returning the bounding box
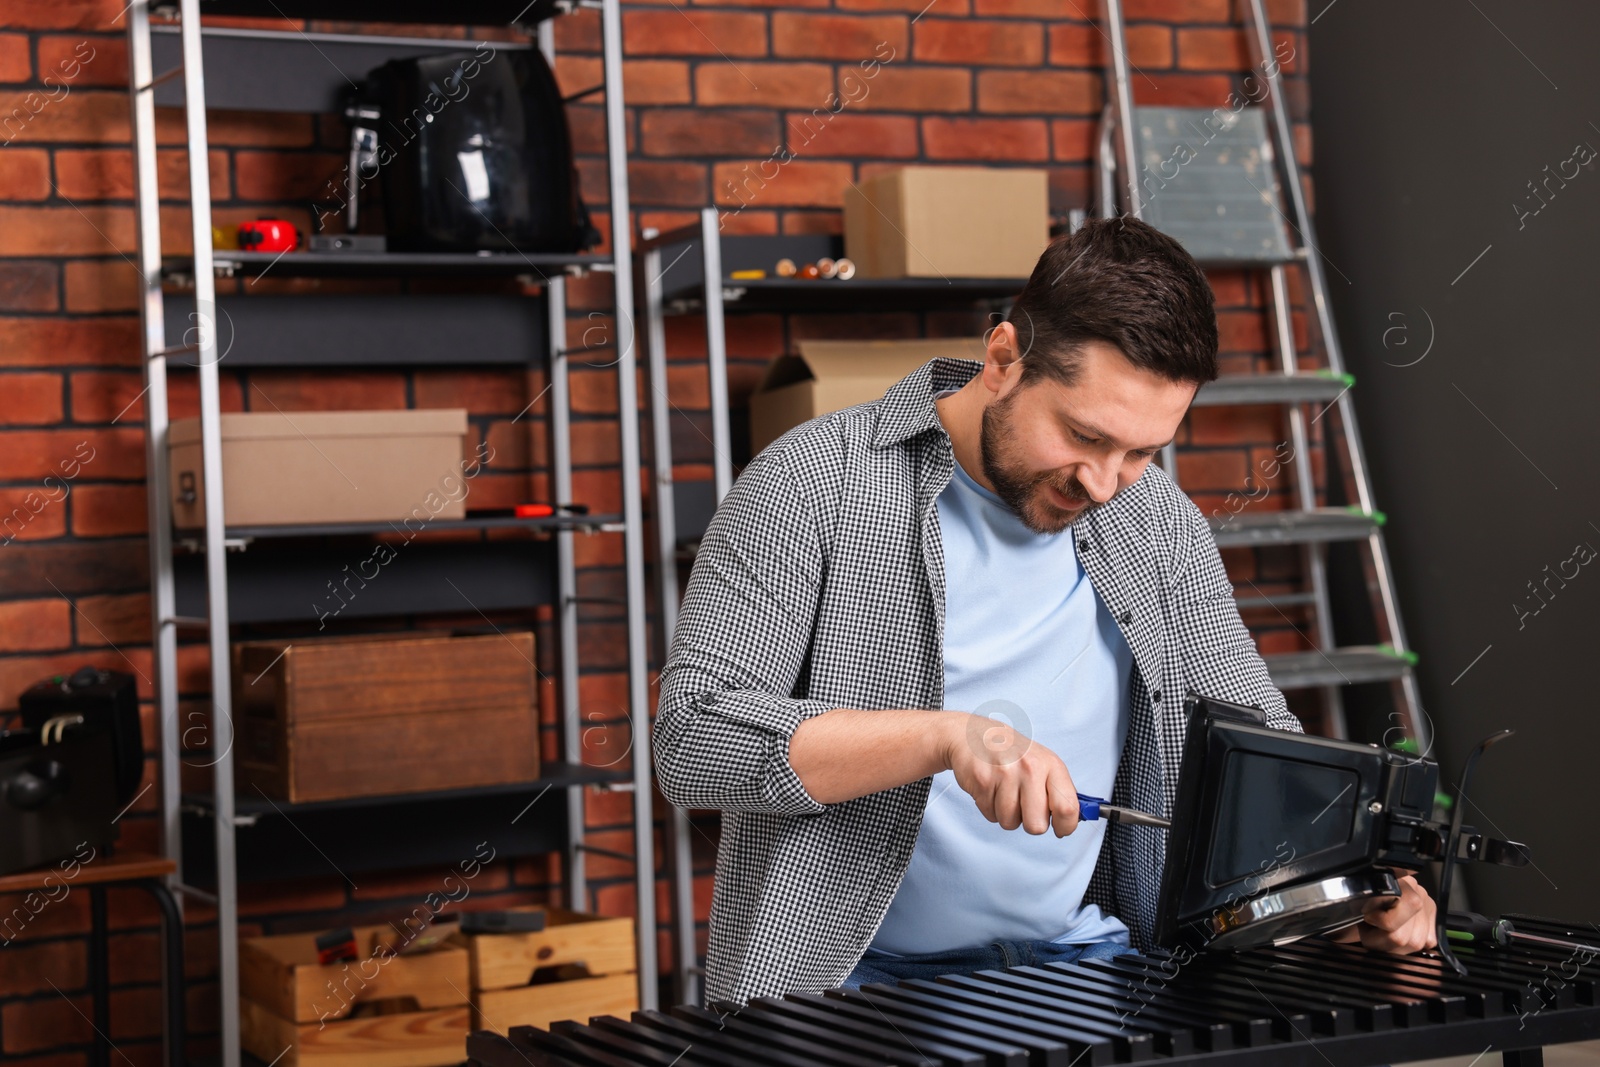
[352,46,600,253]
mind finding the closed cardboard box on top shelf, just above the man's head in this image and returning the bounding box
[845,166,1050,278]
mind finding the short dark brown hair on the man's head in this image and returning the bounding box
[1006,218,1216,386]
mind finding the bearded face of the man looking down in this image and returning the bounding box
[979,341,1195,534]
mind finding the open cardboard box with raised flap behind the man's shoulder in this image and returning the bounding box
[750,338,984,456]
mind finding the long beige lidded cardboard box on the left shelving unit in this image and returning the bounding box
[166,408,469,528]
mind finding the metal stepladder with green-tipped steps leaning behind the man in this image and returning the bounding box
[1098,0,1432,753]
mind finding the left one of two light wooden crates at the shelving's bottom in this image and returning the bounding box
[238,926,470,1067]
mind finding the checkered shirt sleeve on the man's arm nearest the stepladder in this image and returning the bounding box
[1171,501,1304,733]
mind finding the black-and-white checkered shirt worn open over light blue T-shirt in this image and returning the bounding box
[651,358,1301,1003]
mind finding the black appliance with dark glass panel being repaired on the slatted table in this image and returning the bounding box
[1155,693,1528,957]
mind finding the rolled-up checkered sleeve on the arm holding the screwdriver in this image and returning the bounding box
[651,446,832,816]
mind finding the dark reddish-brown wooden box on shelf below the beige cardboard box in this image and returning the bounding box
[234,632,539,803]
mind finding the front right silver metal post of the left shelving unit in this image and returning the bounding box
[600,0,658,1011]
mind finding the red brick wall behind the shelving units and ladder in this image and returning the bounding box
[0,0,1310,1065]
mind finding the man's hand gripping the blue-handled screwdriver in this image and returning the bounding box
[942,715,1078,837]
